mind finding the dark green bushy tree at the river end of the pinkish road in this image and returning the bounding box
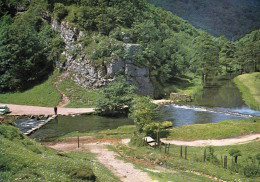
[96,76,135,116]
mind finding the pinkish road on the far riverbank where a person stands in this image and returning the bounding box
[0,103,94,116]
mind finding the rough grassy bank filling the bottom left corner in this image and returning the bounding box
[0,125,118,182]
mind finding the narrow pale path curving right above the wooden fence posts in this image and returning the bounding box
[161,134,260,146]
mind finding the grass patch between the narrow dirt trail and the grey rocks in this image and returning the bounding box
[59,79,100,108]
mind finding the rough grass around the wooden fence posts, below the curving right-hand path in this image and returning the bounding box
[113,142,260,182]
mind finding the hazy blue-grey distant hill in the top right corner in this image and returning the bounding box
[149,0,260,40]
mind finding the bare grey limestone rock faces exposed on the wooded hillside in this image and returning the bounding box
[52,20,154,97]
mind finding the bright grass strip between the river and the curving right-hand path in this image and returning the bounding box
[167,118,260,140]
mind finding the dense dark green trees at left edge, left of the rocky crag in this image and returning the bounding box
[0,7,63,92]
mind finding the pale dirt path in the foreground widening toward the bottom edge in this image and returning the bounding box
[47,137,155,182]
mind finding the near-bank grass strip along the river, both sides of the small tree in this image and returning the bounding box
[61,118,260,141]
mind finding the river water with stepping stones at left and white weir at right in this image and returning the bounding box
[15,81,260,141]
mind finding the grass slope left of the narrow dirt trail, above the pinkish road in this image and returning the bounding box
[0,72,61,107]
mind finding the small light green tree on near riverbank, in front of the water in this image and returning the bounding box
[130,97,157,133]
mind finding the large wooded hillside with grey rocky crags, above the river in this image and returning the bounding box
[0,0,259,101]
